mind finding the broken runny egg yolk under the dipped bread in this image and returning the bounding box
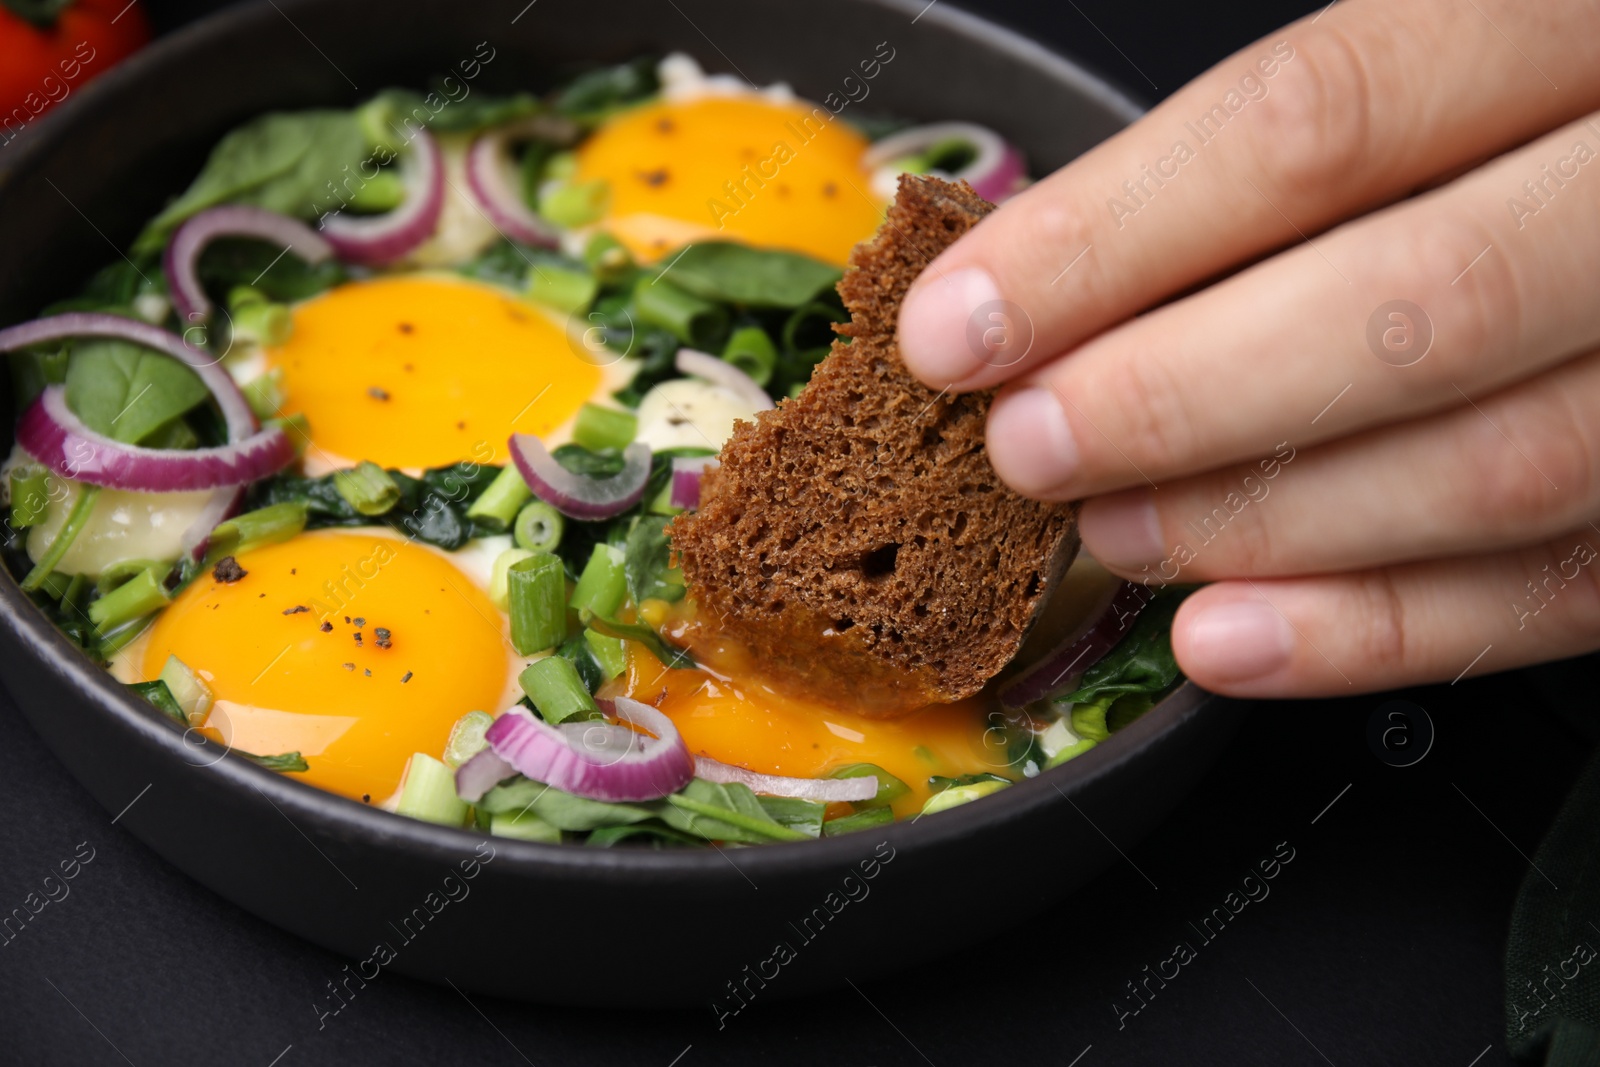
[598,645,1016,817]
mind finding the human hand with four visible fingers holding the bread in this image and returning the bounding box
[899,0,1600,696]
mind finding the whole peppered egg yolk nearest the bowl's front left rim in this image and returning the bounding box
[142,530,515,803]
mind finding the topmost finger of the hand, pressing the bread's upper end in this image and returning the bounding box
[899,0,1600,390]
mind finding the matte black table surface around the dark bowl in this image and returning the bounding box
[0,0,1592,1067]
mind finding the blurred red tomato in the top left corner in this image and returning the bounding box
[0,0,150,144]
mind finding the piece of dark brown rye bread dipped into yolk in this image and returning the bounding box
[672,176,1078,715]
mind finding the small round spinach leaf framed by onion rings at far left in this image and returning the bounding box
[67,339,210,445]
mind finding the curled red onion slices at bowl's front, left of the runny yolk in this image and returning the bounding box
[456,697,694,803]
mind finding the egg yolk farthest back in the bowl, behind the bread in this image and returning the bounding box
[576,96,883,264]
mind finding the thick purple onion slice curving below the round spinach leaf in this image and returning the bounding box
[16,386,294,495]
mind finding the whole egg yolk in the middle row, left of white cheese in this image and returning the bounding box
[267,275,602,469]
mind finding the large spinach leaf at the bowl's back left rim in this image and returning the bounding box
[133,109,370,256]
